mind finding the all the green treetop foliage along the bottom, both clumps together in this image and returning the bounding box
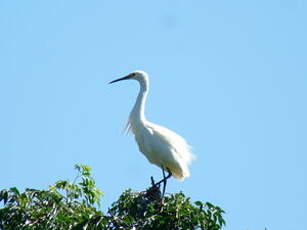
[0,165,225,230]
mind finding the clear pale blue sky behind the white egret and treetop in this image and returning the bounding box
[0,0,307,230]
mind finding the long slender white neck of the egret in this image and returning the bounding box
[130,81,149,124]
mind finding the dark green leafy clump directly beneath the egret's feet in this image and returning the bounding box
[109,187,225,230]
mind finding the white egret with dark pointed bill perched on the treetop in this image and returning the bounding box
[109,70,195,196]
